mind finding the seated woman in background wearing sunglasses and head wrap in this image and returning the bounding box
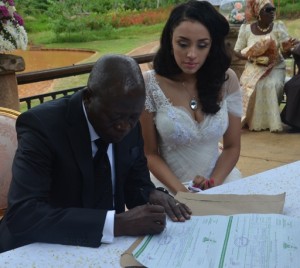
[234,0,297,132]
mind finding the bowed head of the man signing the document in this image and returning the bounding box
[83,54,146,142]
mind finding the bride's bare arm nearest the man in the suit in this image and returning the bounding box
[140,111,188,194]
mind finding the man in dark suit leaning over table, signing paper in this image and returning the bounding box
[0,55,191,252]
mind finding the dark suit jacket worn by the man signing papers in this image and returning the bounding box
[0,91,154,252]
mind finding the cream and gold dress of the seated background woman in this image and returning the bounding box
[234,21,289,132]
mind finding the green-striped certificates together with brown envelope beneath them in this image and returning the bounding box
[121,193,288,268]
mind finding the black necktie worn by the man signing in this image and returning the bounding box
[93,138,113,210]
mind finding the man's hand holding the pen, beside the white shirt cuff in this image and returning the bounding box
[114,204,166,236]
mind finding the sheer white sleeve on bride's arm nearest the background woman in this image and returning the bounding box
[224,69,243,117]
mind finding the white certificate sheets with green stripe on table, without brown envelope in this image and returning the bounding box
[133,214,300,268]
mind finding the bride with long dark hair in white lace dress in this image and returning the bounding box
[141,1,242,193]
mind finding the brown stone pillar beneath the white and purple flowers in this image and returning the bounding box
[0,54,25,111]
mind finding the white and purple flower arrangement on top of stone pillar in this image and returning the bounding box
[0,0,28,53]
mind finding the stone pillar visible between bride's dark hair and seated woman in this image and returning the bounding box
[225,25,246,79]
